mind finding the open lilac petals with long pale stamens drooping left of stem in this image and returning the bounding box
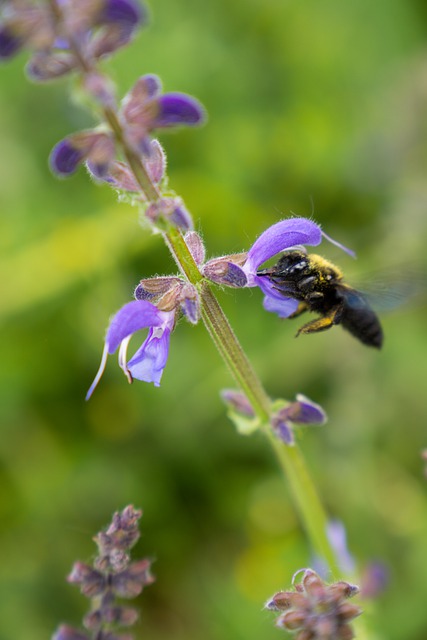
[86,300,175,400]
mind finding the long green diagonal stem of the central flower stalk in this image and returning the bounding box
[88,77,340,578]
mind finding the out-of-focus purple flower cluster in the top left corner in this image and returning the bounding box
[0,0,147,76]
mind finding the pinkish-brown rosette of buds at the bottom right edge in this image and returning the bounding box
[265,569,362,640]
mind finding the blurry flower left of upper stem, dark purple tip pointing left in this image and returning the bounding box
[49,131,115,177]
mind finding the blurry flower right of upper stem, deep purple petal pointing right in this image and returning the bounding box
[120,74,204,155]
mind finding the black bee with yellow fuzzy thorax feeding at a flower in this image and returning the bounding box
[257,250,383,349]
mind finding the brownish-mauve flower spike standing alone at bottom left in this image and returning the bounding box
[52,506,154,640]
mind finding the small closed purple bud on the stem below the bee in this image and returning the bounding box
[271,394,326,445]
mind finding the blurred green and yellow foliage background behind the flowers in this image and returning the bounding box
[0,0,427,640]
